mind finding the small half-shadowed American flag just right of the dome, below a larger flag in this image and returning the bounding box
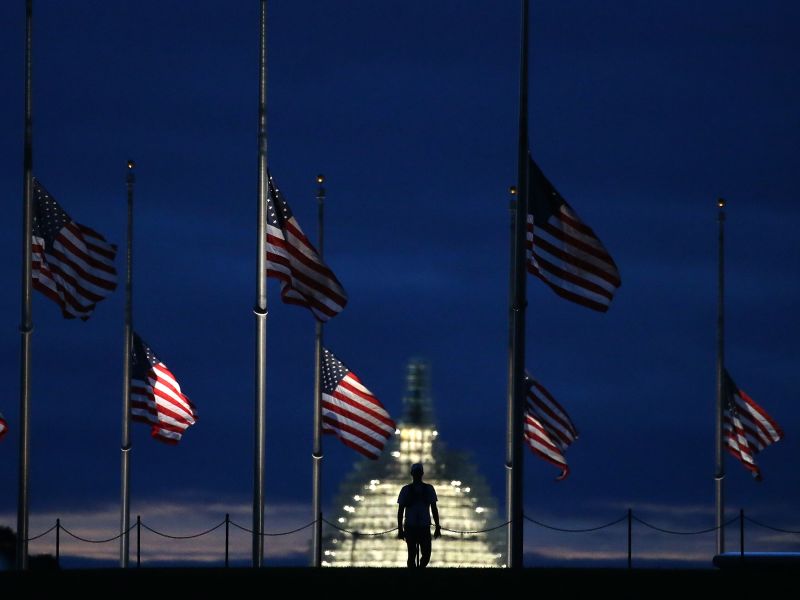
[525,373,578,480]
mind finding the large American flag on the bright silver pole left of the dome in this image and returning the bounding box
[267,177,347,321]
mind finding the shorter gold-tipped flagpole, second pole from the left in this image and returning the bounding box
[119,160,136,569]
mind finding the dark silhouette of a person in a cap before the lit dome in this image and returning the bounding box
[397,463,442,568]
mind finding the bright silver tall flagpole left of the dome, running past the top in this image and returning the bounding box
[253,0,269,567]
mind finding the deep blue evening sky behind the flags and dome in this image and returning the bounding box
[0,0,800,565]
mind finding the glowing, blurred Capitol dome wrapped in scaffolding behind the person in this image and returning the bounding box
[322,360,505,567]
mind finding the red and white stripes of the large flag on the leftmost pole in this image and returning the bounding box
[31,221,117,320]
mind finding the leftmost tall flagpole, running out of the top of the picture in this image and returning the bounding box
[17,0,33,570]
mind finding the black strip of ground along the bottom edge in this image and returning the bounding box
[0,568,798,600]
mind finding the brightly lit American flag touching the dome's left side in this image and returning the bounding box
[322,348,395,460]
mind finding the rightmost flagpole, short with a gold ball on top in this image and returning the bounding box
[714,198,725,554]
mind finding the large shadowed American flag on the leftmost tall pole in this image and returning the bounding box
[31,179,117,321]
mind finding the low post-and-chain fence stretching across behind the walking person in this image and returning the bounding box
[18,509,800,569]
